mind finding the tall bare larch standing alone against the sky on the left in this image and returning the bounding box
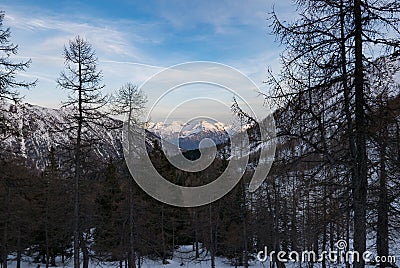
[57,36,108,268]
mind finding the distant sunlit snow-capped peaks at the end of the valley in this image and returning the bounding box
[147,120,230,151]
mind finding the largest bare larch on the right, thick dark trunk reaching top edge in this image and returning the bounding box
[273,0,400,268]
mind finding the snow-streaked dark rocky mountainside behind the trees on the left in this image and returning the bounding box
[0,103,159,168]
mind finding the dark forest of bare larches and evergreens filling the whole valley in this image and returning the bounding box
[0,0,400,268]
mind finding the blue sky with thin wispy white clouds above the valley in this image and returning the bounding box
[0,0,293,122]
